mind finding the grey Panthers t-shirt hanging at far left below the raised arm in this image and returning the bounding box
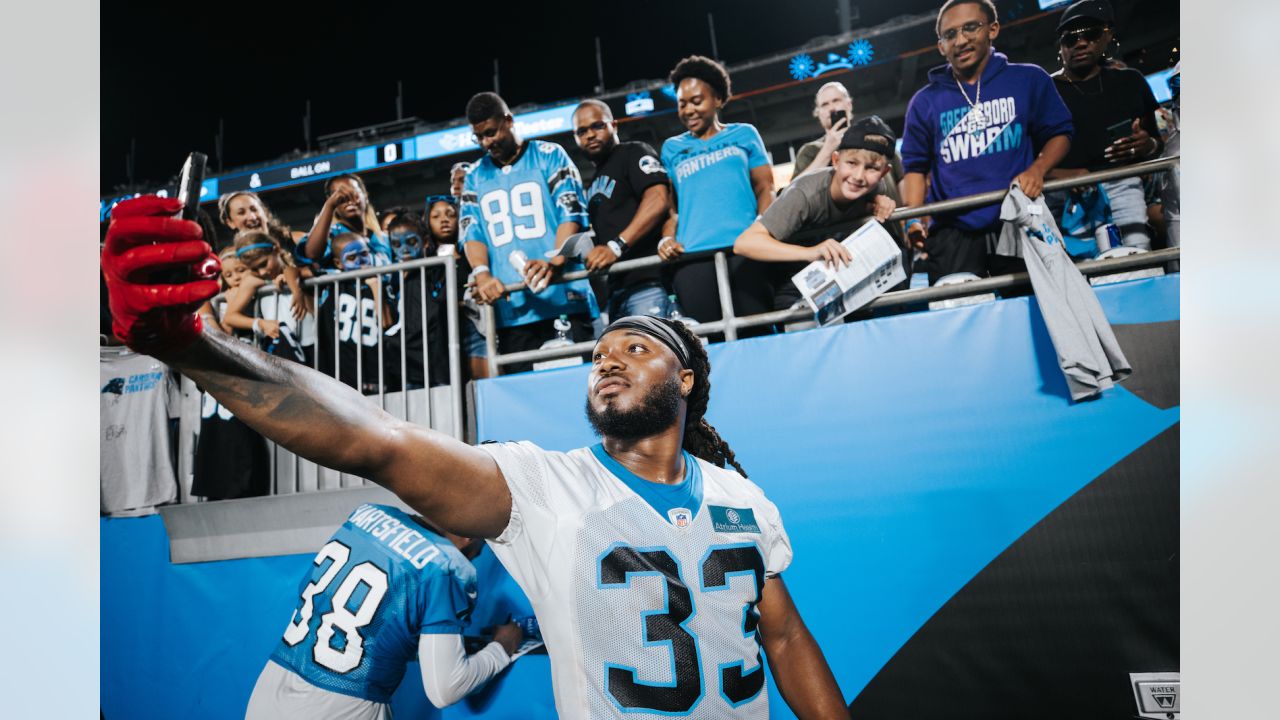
[99,347,180,514]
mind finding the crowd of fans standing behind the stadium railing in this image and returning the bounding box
[97,0,1179,504]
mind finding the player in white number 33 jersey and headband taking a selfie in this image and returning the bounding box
[102,196,849,720]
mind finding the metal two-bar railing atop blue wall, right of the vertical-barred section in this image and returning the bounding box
[481,155,1180,375]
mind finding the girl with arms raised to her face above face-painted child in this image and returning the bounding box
[297,174,392,266]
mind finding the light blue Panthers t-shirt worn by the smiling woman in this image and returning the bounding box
[662,123,769,252]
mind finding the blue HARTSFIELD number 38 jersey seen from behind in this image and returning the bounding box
[271,505,476,702]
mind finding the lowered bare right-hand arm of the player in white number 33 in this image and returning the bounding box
[758,577,849,720]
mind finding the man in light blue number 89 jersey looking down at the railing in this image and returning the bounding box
[458,92,599,373]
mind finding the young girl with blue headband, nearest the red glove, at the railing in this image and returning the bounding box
[224,231,315,364]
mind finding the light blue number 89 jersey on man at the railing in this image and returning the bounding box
[458,140,598,327]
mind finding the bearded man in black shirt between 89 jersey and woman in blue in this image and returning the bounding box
[573,100,671,319]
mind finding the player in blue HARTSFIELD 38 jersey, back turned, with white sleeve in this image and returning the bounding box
[244,505,521,720]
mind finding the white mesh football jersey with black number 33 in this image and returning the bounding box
[480,442,791,720]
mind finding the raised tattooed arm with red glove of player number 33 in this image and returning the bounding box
[102,196,511,537]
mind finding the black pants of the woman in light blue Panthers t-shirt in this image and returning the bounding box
[671,255,773,341]
